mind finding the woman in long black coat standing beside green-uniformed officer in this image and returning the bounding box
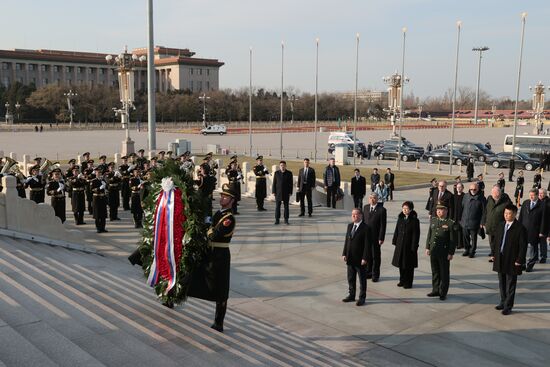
[392,201,420,289]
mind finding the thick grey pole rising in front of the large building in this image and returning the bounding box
[147,0,157,150]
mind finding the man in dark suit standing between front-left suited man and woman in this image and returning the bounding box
[363,192,387,282]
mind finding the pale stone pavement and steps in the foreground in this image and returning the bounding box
[0,184,550,366]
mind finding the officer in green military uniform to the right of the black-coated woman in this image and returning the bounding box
[426,202,458,301]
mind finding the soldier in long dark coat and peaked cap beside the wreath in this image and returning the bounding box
[189,184,236,332]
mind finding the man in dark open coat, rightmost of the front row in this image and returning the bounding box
[491,203,527,315]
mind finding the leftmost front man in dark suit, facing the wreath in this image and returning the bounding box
[342,208,373,306]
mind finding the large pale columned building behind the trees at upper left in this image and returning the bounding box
[0,46,224,92]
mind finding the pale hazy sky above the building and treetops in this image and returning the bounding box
[0,0,550,98]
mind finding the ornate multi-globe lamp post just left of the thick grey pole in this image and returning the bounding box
[105,47,146,155]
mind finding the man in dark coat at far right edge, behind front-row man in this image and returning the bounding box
[518,189,544,272]
